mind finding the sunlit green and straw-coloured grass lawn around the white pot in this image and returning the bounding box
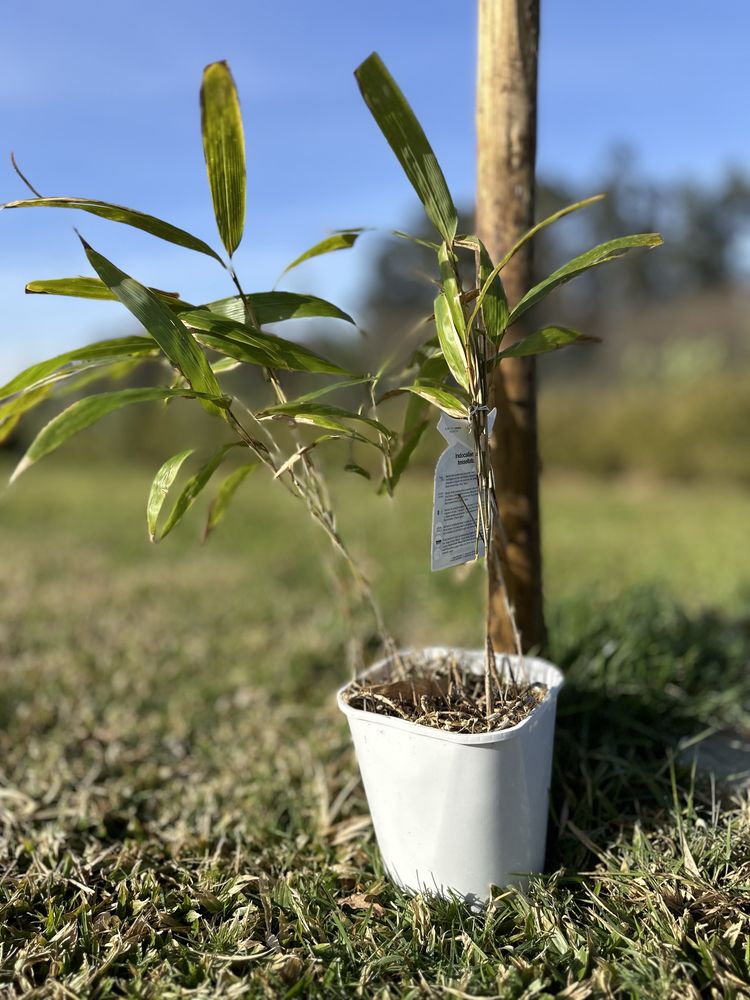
[0,457,750,998]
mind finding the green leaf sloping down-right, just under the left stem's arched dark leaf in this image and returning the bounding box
[185,309,351,376]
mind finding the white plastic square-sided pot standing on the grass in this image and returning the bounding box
[338,648,563,904]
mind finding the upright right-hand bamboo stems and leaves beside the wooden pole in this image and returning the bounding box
[355,53,662,717]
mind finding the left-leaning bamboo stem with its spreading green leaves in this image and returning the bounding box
[0,62,394,645]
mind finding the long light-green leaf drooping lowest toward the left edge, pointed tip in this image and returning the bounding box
[10,386,229,482]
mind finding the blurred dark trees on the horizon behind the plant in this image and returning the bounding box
[361,148,750,380]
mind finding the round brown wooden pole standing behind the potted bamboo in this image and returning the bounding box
[477,0,545,652]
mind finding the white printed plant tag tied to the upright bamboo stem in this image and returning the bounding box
[431,410,495,572]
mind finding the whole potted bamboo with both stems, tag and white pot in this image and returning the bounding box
[0,55,661,912]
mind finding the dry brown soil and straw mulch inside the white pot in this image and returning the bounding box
[342,652,547,733]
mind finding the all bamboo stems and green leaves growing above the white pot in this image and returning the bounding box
[0,54,661,717]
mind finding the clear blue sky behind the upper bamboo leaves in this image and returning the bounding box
[0,0,750,378]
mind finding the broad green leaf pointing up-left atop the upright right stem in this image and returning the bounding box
[354,52,458,246]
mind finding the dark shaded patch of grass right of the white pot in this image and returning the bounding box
[547,590,750,870]
